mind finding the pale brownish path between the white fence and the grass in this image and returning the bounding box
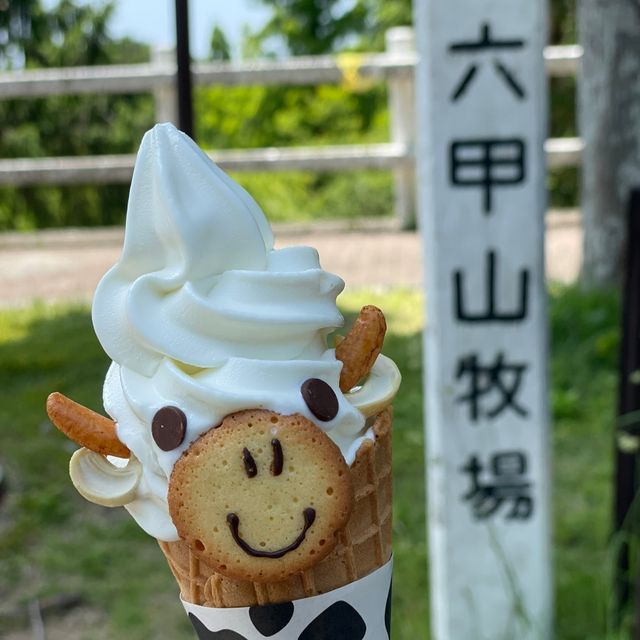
[0,212,582,308]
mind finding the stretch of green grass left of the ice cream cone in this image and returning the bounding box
[0,306,193,639]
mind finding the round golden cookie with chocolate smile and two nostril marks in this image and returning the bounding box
[169,410,353,582]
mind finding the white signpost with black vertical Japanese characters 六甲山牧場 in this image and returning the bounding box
[415,0,552,640]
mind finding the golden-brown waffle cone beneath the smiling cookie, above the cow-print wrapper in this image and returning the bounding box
[160,407,392,607]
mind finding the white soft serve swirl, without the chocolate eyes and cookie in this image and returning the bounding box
[93,124,367,540]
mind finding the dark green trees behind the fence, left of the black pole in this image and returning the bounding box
[0,0,153,229]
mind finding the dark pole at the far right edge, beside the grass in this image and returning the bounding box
[614,189,640,624]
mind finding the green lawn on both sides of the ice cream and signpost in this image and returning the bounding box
[0,289,626,640]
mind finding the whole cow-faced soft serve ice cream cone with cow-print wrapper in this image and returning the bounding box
[49,123,401,640]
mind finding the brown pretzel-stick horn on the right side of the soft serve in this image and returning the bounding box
[336,305,387,393]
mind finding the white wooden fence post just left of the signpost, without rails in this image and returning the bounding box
[385,27,416,229]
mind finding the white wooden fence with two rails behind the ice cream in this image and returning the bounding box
[0,27,582,226]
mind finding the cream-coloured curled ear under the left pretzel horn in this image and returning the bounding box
[69,447,142,507]
